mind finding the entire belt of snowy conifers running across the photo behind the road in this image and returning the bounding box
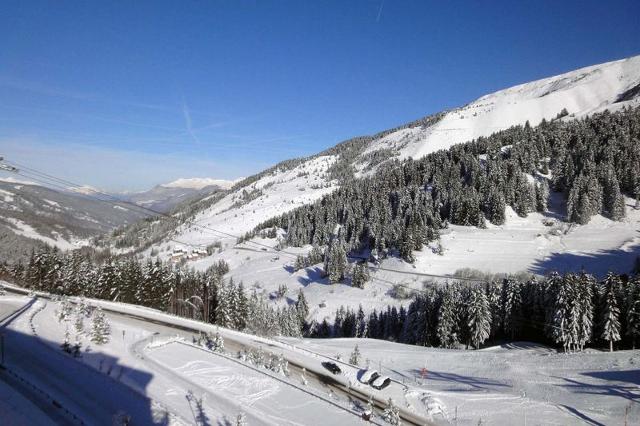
[0,249,640,351]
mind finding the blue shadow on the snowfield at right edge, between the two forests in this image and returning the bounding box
[529,240,640,278]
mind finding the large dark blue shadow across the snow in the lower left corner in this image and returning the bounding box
[0,298,169,425]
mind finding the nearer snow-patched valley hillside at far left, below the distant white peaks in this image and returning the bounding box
[0,178,145,260]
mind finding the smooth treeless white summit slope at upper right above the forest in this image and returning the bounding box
[367,56,640,162]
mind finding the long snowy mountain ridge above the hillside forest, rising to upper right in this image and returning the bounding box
[146,56,640,251]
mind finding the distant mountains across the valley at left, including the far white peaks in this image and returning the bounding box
[0,177,238,261]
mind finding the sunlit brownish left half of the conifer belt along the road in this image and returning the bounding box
[0,248,308,336]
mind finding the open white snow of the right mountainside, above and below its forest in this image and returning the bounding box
[127,56,640,326]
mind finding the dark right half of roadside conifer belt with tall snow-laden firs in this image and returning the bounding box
[318,273,640,351]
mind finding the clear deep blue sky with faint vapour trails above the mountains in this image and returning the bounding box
[0,0,640,190]
